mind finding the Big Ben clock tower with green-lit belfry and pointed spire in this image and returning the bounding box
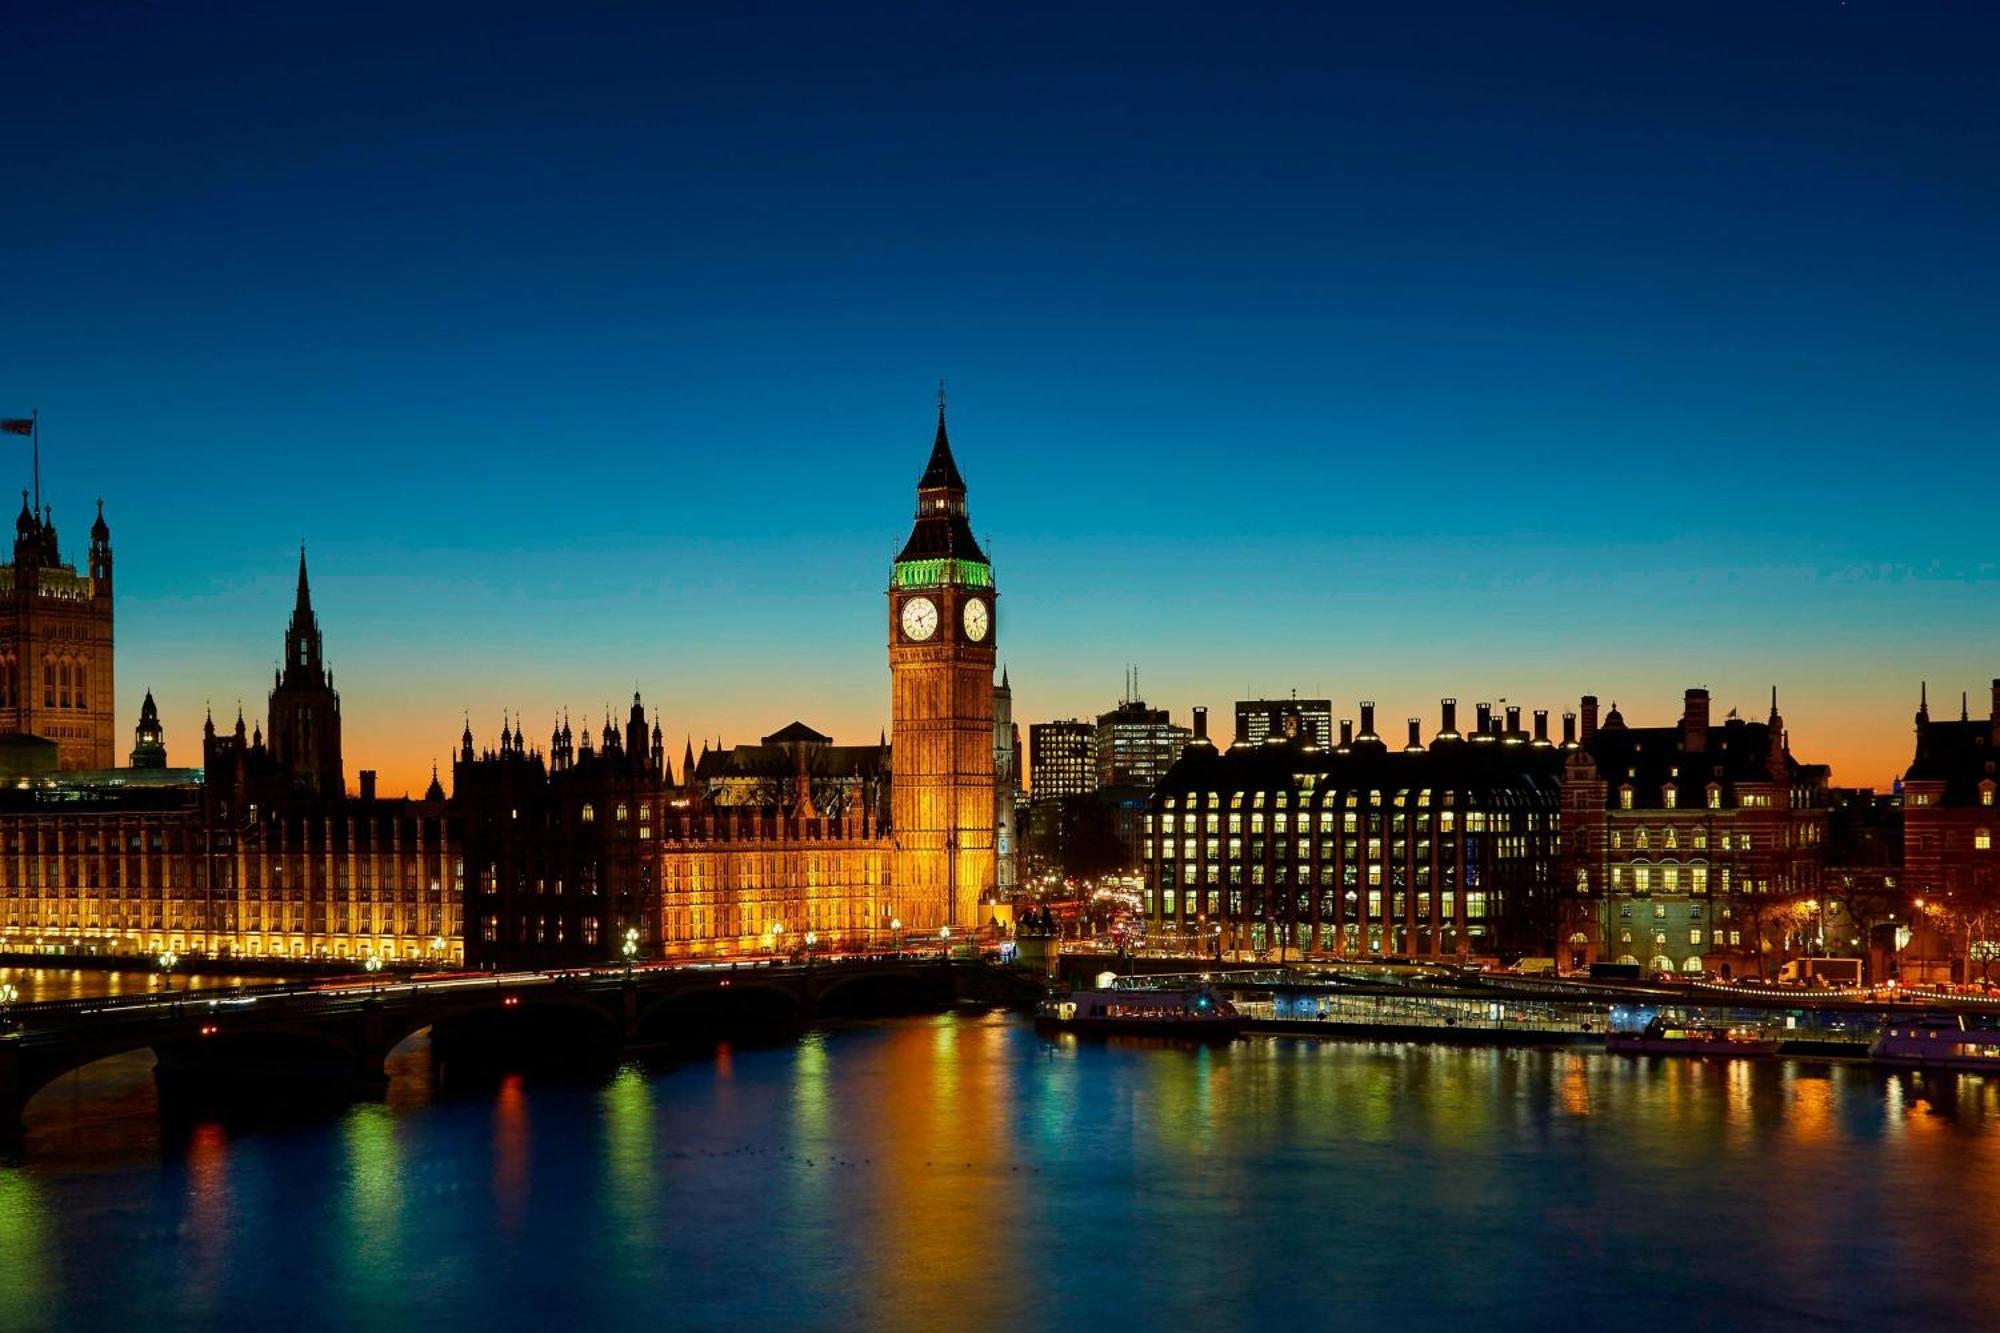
[888,394,996,933]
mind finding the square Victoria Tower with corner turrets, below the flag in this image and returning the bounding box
[0,492,118,771]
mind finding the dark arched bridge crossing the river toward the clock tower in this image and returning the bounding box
[0,953,1040,1157]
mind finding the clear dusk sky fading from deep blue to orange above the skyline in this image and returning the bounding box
[0,0,2000,791]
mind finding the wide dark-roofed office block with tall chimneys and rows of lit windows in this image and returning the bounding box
[1144,701,1564,959]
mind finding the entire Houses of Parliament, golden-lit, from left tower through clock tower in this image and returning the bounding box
[0,404,1012,967]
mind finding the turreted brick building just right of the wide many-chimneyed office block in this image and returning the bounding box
[1558,689,1828,977]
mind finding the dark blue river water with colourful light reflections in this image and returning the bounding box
[0,964,2000,1331]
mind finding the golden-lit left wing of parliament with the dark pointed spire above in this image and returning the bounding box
[0,576,462,965]
